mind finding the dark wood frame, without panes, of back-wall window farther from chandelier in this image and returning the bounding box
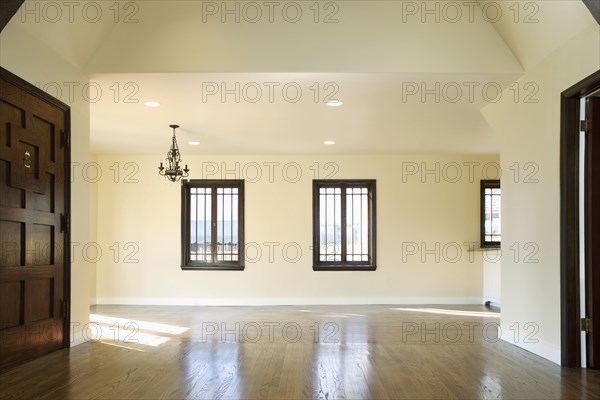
[313,179,377,271]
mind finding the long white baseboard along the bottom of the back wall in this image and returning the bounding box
[96,297,483,306]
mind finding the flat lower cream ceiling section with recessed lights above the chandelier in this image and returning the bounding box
[91,73,510,154]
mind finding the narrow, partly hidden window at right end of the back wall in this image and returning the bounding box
[480,180,501,247]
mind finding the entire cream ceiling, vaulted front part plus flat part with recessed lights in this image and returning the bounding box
[9,0,595,154]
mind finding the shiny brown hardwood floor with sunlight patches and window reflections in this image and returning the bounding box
[0,305,600,399]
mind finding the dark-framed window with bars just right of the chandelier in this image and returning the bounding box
[181,179,244,270]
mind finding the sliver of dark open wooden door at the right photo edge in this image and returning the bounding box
[585,97,600,368]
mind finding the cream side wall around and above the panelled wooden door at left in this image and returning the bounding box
[0,23,90,343]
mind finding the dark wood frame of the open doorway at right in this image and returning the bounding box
[560,70,600,367]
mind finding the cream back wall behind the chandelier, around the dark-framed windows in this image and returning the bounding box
[95,155,498,304]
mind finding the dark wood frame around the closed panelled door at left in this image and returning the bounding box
[0,67,71,348]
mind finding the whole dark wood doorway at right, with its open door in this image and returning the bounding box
[560,71,600,368]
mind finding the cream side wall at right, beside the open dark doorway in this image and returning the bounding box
[483,24,600,363]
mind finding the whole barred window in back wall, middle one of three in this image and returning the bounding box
[313,180,376,271]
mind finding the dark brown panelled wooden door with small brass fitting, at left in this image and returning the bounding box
[0,68,70,371]
